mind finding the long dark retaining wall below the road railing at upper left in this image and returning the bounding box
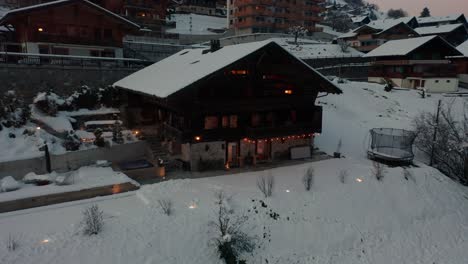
[0,64,140,99]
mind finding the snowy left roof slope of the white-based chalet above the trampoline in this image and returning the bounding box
[364,36,439,58]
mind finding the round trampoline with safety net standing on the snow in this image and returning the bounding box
[367,128,416,163]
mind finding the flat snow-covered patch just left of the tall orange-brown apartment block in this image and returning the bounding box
[166,14,227,35]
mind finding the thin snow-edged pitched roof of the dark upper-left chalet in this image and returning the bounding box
[0,0,140,28]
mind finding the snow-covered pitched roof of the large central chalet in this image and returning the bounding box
[113,40,341,98]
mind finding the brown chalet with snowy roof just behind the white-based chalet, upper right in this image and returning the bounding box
[338,17,419,53]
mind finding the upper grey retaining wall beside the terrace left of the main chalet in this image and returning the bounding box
[0,141,148,180]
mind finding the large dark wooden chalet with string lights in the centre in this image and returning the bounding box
[114,40,341,170]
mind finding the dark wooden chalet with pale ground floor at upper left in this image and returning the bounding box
[0,0,139,57]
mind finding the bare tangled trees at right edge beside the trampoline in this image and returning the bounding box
[413,103,468,185]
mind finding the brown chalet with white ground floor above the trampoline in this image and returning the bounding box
[364,36,461,92]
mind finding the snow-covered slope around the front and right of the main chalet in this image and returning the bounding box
[0,82,468,264]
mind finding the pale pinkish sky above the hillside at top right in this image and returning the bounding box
[368,0,468,16]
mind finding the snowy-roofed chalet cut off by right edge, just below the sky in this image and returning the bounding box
[415,24,468,46]
